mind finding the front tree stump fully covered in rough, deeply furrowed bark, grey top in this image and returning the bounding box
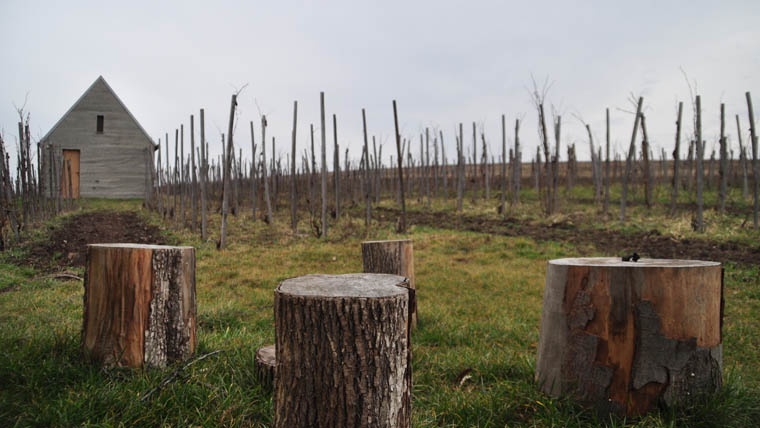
[274,274,414,428]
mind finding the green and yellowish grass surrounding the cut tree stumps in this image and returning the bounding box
[0,189,760,427]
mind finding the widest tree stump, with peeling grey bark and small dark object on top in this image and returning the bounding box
[536,258,723,415]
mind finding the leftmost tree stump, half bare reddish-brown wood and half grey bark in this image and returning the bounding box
[82,244,196,367]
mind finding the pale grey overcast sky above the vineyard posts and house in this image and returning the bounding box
[0,0,760,171]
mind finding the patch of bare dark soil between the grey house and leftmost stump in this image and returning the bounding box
[17,211,166,270]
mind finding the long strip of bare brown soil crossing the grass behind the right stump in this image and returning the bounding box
[376,207,760,265]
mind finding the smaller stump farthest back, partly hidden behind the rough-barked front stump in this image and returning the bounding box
[362,239,417,327]
